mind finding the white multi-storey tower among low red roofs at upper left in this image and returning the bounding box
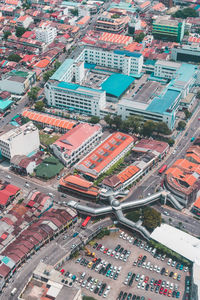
[35,22,57,44]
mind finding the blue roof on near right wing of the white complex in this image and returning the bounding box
[146,89,180,113]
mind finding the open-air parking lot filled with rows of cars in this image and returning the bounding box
[59,233,188,300]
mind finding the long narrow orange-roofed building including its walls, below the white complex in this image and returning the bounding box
[22,110,76,133]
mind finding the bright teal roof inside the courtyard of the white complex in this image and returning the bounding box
[101,74,134,97]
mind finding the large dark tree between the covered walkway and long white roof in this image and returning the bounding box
[143,207,162,231]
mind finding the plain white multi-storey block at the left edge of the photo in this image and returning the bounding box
[0,122,40,159]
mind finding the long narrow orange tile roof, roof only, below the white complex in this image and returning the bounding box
[22,110,76,130]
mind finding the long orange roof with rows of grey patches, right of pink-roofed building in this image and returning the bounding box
[77,132,134,177]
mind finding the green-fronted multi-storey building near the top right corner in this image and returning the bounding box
[152,16,185,42]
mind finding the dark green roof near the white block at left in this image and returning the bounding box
[35,156,64,179]
